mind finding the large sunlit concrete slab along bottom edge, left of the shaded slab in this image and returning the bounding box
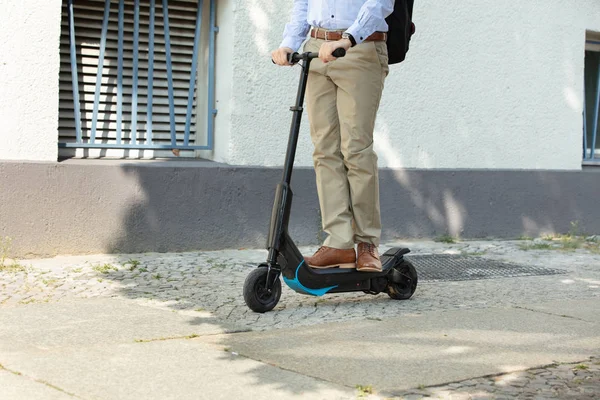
[2,339,356,400]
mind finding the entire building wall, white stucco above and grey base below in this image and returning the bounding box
[0,0,600,256]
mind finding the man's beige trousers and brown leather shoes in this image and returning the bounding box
[304,33,389,271]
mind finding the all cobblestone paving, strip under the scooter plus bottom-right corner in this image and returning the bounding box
[0,239,600,399]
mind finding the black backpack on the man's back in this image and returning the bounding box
[385,0,415,64]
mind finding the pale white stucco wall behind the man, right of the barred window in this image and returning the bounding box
[216,0,600,169]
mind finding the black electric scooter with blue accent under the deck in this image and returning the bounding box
[244,49,418,313]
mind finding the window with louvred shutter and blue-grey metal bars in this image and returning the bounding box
[59,0,216,157]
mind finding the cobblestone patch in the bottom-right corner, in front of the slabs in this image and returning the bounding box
[389,357,600,400]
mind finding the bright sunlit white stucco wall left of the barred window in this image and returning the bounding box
[0,0,61,161]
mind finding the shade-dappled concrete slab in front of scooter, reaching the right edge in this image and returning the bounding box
[201,302,600,391]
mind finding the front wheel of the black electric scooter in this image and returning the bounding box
[244,267,281,313]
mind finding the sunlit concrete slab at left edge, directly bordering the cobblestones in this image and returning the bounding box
[0,298,244,352]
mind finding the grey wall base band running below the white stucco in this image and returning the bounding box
[0,160,600,257]
